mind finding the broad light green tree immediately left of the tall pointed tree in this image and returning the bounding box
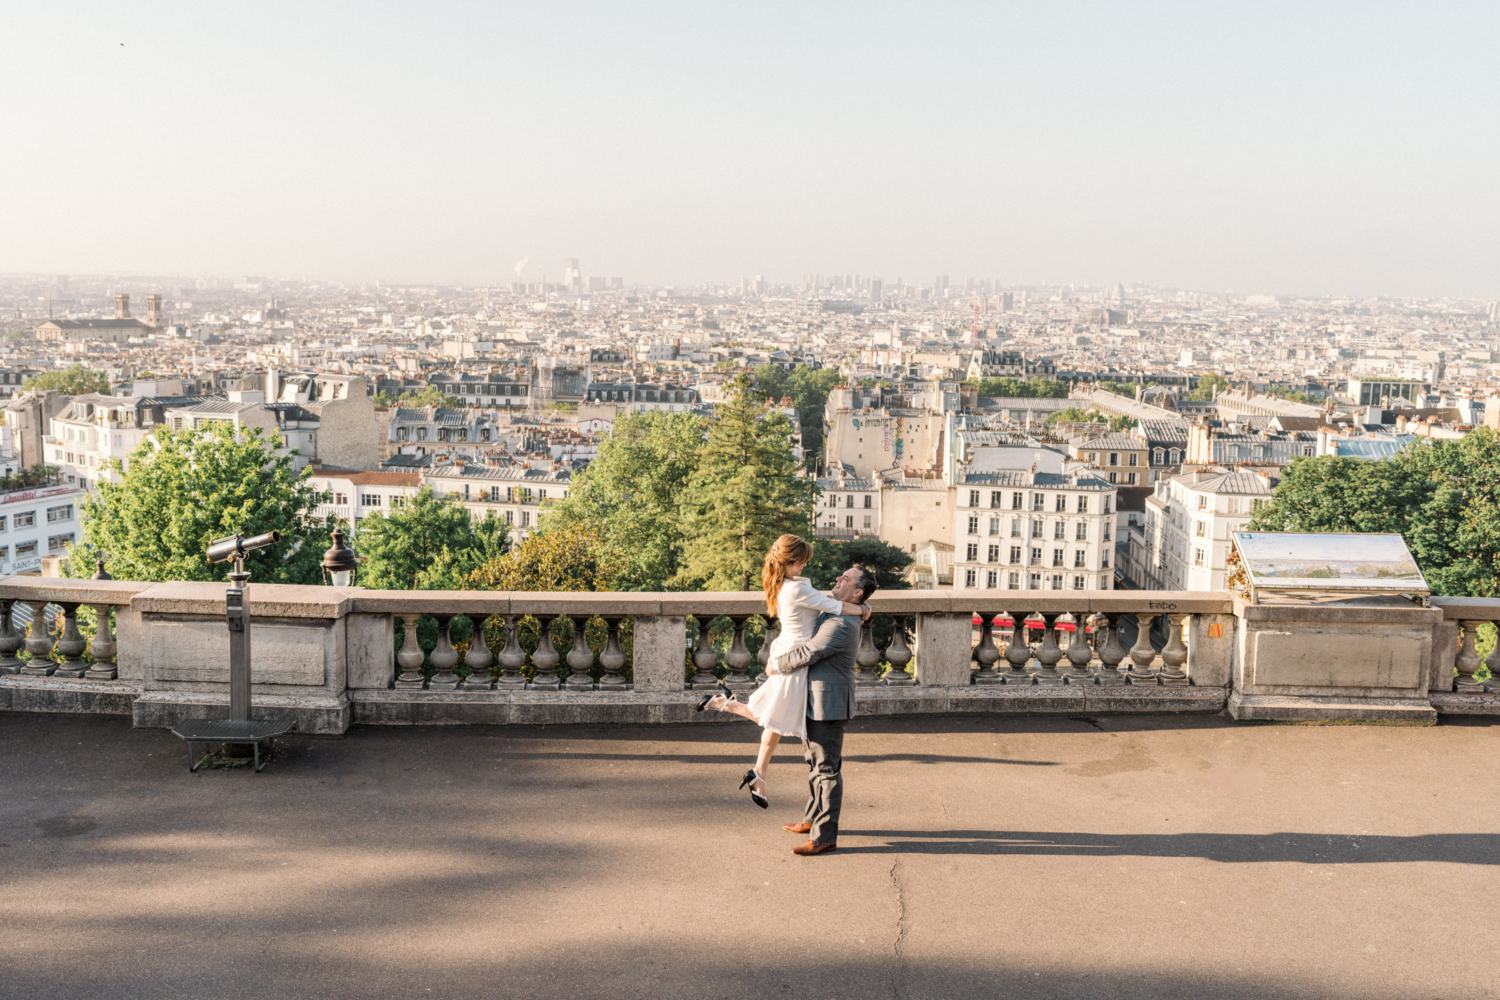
[539,412,708,591]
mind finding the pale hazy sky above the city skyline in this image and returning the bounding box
[0,0,1500,298]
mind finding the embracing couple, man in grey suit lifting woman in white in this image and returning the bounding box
[698,535,876,856]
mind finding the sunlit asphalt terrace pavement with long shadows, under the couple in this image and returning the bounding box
[0,714,1500,1000]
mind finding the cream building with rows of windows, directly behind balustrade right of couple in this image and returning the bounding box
[953,472,1116,591]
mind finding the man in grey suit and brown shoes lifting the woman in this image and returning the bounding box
[777,565,875,858]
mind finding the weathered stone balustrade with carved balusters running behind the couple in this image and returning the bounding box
[0,577,1476,733]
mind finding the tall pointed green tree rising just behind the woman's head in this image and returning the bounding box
[675,378,818,591]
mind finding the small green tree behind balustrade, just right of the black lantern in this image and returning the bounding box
[354,486,486,591]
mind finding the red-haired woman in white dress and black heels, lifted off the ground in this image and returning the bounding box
[698,535,870,810]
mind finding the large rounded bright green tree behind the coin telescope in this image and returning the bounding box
[68,424,332,583]
